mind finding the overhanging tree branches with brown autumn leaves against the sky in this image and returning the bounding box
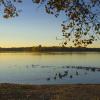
[0,0,100,47]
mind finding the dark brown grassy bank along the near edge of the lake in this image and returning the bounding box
[0,84,100,100]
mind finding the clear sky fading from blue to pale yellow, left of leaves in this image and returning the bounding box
[0,0,100,47]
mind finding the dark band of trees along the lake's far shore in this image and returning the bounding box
[0,46,100,52]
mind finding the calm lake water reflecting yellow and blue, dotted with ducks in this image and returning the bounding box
[0,52,100,84]
